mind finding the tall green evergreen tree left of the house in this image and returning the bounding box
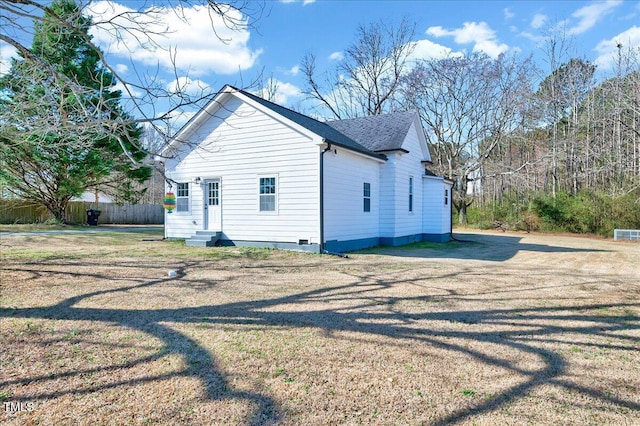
[0,0,151,222]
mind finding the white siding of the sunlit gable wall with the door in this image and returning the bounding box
[165,97,321,243]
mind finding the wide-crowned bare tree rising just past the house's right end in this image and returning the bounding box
[403,54,532,223]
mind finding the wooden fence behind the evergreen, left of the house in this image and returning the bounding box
[0,200,164,225]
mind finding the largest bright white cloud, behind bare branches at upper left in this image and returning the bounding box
[89,0,262,75]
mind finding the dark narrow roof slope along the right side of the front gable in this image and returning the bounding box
[234,86,386,159]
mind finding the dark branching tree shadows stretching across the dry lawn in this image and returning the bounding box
[0,255,640,425]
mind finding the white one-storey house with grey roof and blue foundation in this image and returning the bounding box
[162,86,451,252]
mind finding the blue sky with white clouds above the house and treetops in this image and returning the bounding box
[0,0,640,122]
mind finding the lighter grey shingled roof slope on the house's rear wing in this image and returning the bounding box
[327,111,417,152]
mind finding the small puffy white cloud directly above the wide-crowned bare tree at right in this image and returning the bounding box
[427,22,509,58]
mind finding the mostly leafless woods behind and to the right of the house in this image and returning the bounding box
[303,21,640,235]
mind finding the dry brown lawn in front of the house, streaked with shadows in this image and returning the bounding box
[0,233,640,425]
